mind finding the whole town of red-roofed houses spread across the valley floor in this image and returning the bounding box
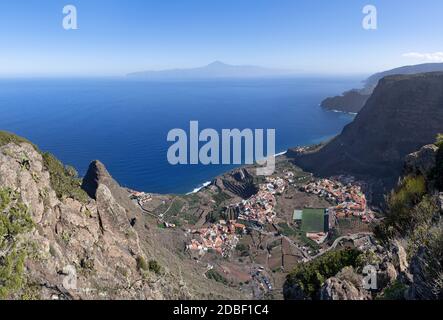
[130,170,374,259]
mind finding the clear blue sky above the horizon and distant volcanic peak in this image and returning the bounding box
[0,0,443,76]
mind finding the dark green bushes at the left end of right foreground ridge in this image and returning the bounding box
[286,249,361,299]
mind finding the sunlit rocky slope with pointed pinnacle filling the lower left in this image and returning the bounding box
[0,134,246,299]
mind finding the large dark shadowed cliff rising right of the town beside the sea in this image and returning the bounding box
[294,73,443,200]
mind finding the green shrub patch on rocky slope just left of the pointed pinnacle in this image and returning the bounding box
[42,153,89,203]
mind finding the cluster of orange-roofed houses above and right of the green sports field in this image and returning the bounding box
[302,179,370,221]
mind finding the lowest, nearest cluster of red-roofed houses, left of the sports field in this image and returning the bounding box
[187,220,246,257]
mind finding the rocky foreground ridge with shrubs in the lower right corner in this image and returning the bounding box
[284,141,443,300]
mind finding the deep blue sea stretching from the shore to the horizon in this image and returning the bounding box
[0,78,360,193]
